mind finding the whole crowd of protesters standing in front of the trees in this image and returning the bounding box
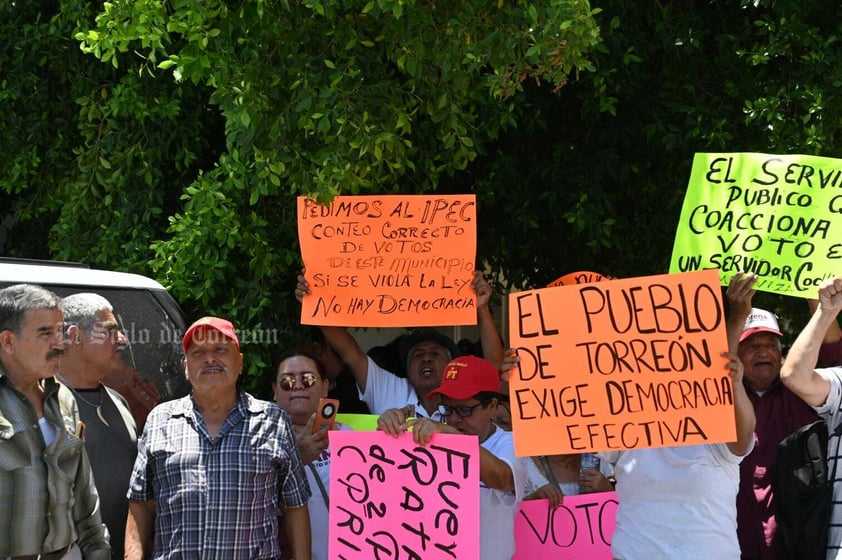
[0,273,842,560]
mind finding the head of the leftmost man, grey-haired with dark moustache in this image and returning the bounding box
[0,309,64,379]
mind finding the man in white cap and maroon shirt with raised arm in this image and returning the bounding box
[726,273,818,560]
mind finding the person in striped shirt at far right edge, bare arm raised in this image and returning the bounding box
[781,276,842,560]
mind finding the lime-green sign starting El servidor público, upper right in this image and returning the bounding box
[670,153,842,298]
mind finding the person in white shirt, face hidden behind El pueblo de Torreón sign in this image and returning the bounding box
[600,352,755,560]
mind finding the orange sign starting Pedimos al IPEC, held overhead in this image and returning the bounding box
[298,195,477,327]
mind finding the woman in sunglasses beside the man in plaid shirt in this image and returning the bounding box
[272,351,350,560]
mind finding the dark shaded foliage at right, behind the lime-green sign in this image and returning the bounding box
[472,0,842,328]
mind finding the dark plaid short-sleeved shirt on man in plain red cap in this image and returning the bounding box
[128,392,310,560]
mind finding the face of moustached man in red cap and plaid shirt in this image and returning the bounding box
[184,328,243,394]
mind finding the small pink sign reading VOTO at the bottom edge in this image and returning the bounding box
[512,492,618,560]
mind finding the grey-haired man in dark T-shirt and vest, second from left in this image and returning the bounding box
[58,293,137,560]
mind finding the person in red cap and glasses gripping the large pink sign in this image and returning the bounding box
[377,356,527,560]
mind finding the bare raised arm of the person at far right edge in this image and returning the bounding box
[781,276,842,406]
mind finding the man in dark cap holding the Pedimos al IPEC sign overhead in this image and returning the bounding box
[295,272,503,419]
